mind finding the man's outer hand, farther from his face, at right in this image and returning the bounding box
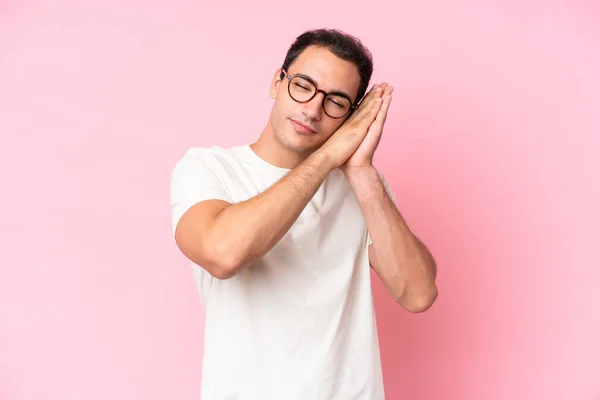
[342,83,394,173]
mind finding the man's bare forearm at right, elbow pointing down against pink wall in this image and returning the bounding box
[346,168,437,311]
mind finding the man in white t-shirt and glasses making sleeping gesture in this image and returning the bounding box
[171,30,437,400]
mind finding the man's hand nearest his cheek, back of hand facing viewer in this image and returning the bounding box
[317,85,383,169]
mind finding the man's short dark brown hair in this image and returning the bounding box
[281,29,373,104]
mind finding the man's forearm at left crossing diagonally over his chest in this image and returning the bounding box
[212,153,332,269]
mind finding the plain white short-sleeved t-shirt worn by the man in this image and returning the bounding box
[171,145,393,400]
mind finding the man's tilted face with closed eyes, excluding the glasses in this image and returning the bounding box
[270,46,360,155]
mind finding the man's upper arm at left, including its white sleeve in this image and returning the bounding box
[171,152,233,275]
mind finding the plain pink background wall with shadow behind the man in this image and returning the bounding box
[0,0,600,400]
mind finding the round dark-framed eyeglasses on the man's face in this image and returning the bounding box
[282,70,356,119]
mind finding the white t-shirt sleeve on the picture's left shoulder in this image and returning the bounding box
[171,152,232,235]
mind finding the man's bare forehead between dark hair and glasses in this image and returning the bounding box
[288,46,360,98]
